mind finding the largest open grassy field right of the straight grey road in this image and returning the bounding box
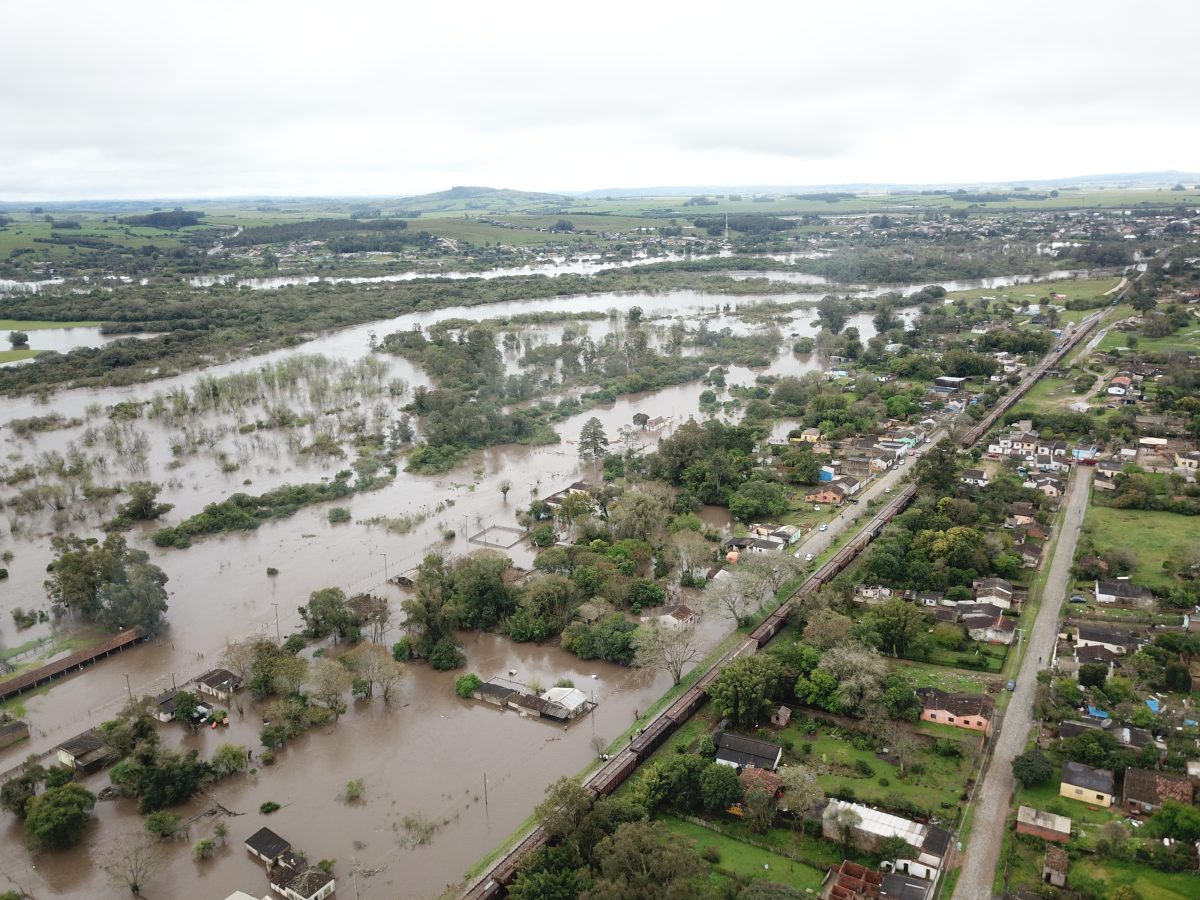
[1084,503,1200,588]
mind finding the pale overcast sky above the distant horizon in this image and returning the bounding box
[0,0,1200,199]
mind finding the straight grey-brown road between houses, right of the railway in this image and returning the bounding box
[954,466,1094,900]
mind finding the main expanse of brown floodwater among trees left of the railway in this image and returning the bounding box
[0,264,1003,898]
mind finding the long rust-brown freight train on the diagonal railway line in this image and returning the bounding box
[463,310,1105,900]
